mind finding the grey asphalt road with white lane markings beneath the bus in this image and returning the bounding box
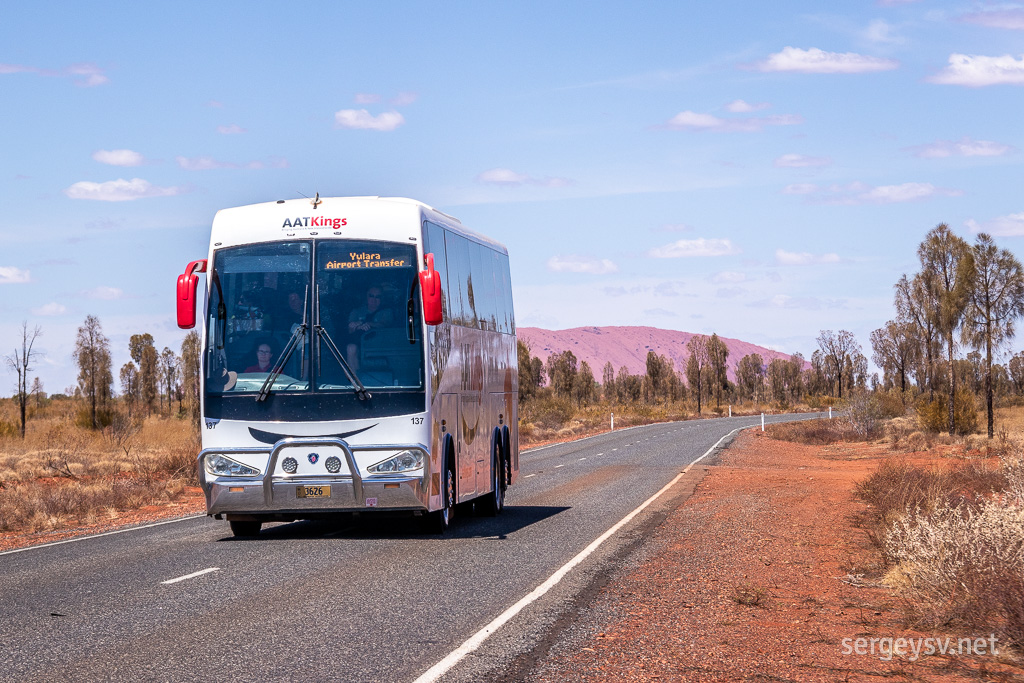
[0,416,816,681]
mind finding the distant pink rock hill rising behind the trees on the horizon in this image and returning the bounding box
[516,327,810,382]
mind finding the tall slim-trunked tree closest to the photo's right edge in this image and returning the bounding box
[964,232,1024,438]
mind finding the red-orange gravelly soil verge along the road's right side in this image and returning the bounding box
[521,431,1024,683]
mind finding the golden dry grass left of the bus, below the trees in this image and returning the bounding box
[0,399,200,531]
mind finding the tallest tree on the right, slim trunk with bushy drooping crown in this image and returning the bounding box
[918,223,975,434]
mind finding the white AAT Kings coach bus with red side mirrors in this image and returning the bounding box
[177,196,519,536]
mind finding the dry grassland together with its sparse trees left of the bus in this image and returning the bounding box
[0,315,200,532]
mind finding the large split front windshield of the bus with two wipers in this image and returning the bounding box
[206,239,424,399]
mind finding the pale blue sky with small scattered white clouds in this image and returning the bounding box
[0,0,1024,395]
